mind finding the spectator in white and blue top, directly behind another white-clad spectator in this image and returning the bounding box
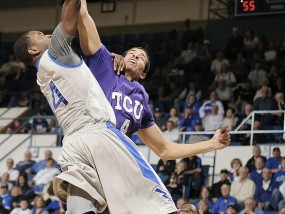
[199,91,224,119]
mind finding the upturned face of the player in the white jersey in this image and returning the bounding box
[28,31,51,52]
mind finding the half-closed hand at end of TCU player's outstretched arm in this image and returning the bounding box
[212,126,231,150]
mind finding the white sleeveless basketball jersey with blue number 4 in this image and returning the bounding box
[37,51,116,135]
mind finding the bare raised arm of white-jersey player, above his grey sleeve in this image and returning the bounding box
[61,0,81,36]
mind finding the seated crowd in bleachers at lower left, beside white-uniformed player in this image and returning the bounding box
[0,150,65,214]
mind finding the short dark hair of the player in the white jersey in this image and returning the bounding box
[14,32,33,66]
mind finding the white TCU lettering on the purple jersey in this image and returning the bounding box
[112,92,143,120]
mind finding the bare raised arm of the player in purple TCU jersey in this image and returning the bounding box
[78,0,101,56]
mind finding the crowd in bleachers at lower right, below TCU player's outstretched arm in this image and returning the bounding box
[156,145,285,214]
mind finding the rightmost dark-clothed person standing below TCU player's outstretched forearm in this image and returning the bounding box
[181,155,202,198]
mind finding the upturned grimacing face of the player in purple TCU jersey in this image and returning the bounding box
[125,48,148,80]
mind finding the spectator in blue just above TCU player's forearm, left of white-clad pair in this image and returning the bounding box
[178,106,196,132]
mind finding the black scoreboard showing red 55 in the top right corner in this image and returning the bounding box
[235,0,285,16]
